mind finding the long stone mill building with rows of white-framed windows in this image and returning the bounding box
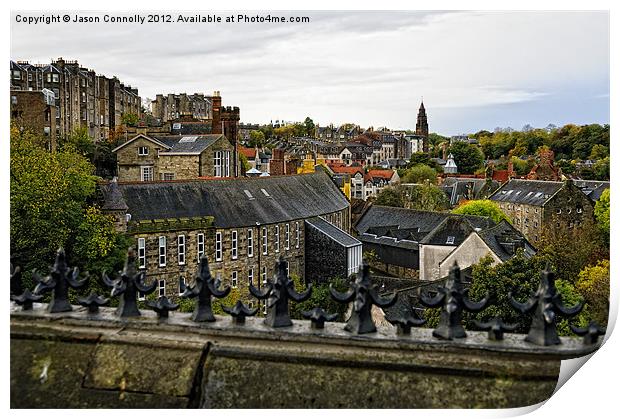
[101,170,361,312]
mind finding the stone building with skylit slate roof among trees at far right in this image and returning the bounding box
[489,179,594,245]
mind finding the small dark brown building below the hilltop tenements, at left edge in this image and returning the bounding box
[11,89,56,151]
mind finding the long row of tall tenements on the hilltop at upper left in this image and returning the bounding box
[10,58,142,140]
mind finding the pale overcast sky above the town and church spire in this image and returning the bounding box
[11,11,609,135]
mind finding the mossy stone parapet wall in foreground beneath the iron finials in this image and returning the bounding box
[10,304,597,408]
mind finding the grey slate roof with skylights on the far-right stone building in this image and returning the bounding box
[489,179,564,207]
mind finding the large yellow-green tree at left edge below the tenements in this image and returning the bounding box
[10,124,96,282]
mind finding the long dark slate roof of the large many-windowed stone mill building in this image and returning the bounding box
[101,171,349,228]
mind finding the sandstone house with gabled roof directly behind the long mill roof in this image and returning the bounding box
[112,134,236,182]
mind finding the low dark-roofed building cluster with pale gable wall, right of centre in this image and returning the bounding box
[355,205,535,281]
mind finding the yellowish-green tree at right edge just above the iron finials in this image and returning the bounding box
[576,259,609,326]
